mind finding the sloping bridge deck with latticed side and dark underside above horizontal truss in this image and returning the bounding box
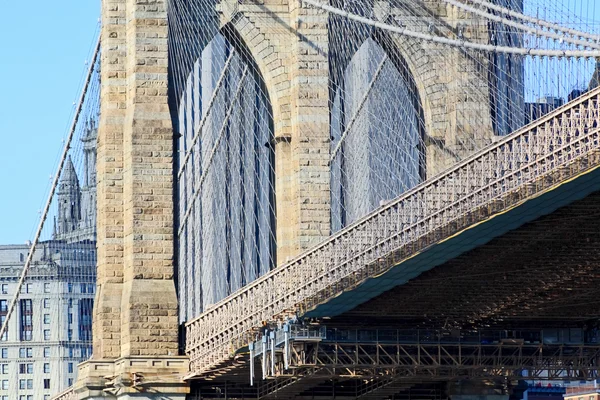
[186,88,600,394]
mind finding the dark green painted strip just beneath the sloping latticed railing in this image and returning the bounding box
[304,164,600,318]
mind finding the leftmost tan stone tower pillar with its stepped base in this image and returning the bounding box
[74,0,189,399]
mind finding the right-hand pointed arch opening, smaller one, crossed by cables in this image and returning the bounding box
[330,30,426,232]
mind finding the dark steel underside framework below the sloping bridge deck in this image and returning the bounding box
[191,159,600,398]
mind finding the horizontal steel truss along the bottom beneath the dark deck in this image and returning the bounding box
[189,340,600,399]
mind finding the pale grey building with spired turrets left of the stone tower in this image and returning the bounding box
[0,124,96,400]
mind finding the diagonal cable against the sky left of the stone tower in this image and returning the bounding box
[0,37,100,344]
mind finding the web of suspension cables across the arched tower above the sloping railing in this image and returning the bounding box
[169,0,600,322]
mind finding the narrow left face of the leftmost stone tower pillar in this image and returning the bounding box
[93,0,127,358]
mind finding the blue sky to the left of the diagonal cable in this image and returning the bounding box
[0,0,100,244]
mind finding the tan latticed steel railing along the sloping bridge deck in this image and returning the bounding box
[186,88,600,374]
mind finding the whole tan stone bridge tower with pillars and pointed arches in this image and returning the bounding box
[68,0,520,399]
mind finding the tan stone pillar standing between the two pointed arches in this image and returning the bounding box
[276,0,331,264]
